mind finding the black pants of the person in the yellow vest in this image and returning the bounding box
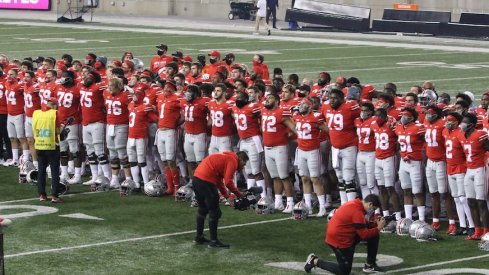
[36,148,59,197]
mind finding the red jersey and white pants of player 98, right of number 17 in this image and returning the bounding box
[372,117,397,187]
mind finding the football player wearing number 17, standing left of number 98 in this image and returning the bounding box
[355,102,379,198]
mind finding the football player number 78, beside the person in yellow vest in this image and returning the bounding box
[53,71,82,184]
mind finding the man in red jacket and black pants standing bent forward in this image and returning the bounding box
[192,151,248,248]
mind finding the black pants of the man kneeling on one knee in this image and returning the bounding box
[317,235,380,275]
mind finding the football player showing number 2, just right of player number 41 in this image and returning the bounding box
[443,112,474,235]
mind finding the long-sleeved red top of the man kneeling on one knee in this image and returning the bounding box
[324,199,379,248]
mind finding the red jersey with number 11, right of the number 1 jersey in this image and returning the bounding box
[181,97,209,135]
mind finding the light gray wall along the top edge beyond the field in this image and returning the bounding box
[62,0,489,21]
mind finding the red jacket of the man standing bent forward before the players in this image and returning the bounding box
[194,151,241,198]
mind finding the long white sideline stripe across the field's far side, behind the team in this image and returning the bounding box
[4,21,489,55]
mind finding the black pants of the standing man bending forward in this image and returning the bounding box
[192,177,222,241]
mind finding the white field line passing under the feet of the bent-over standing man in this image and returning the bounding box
[5,217,292,259]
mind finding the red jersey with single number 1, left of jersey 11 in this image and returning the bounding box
[156,94,181,129]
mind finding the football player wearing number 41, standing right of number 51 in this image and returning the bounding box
[423,105,455,230]
